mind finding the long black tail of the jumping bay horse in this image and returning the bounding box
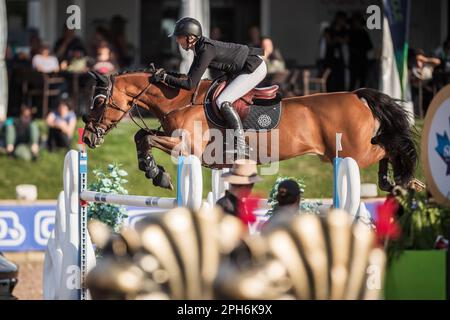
[354,88,418,186]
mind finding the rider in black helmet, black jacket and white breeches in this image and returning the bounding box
[152,17,267,158]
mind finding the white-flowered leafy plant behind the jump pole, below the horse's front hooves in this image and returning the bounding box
[88,163,128,232]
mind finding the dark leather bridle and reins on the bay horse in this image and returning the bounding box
[89,75,204,139]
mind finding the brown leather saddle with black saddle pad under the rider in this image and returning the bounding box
[205,78,281,130]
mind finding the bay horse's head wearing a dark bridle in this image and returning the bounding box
[83,71,129,148]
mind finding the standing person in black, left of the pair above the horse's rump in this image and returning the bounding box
[323,11,348,92]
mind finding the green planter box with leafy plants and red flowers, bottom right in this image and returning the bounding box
[376,187,450,300]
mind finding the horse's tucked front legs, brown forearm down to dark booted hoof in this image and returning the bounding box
[134,129,180,190]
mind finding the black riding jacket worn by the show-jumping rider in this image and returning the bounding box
[165,37,264,90]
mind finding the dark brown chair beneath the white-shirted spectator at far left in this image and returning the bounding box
[22,70,65,118]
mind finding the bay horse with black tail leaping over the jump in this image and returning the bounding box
[83,66,418,191]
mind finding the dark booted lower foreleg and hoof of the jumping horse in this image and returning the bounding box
[134,129,173,190]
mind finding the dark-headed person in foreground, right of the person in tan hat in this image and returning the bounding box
[262,179,301,231]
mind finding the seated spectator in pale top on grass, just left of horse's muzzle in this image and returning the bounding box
[46,99,77,152]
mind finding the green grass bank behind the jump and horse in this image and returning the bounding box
[0,120,423,200]
